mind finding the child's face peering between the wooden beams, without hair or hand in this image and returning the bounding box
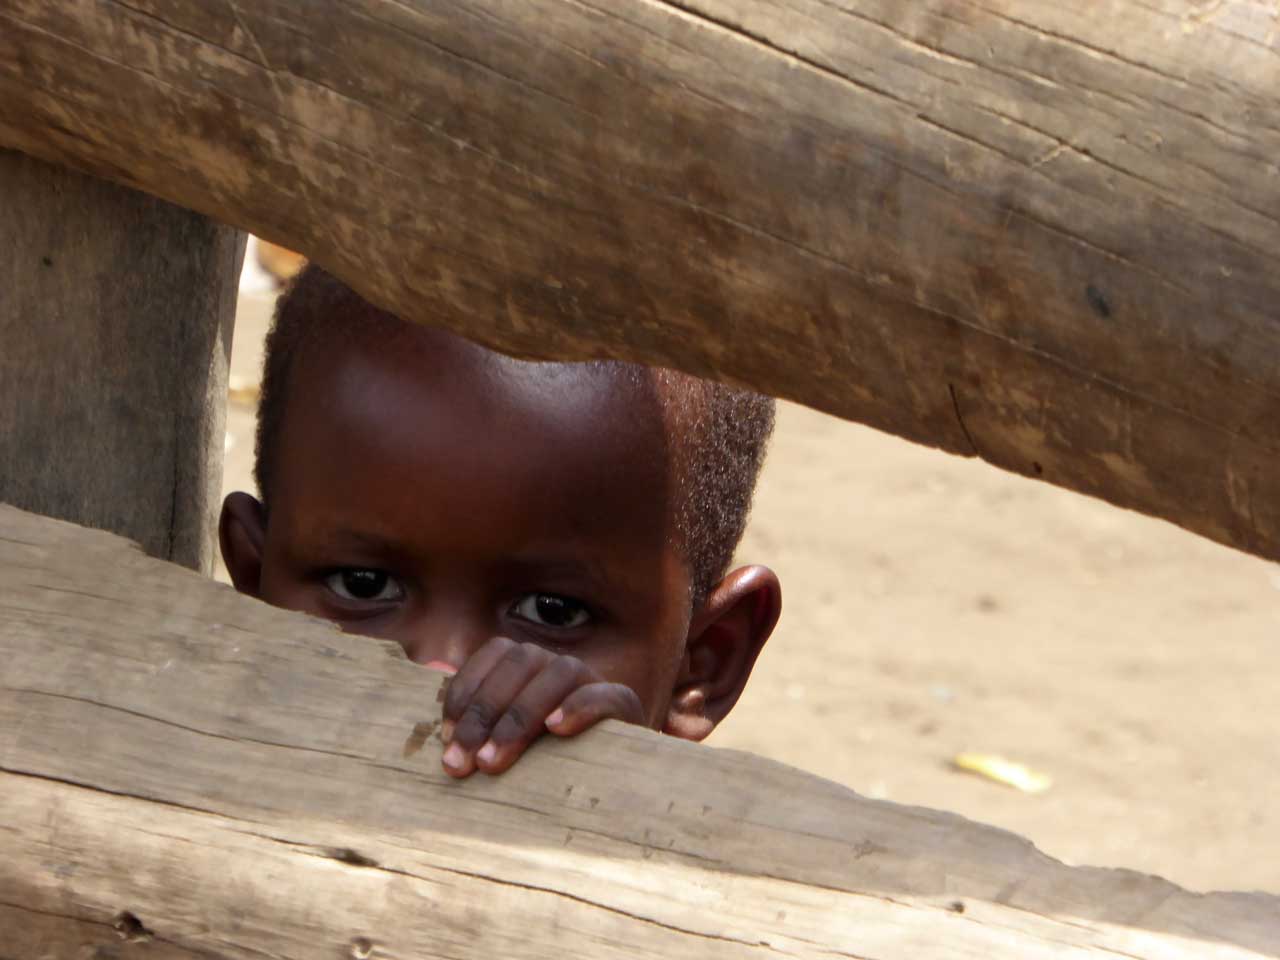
[224,329,716,727]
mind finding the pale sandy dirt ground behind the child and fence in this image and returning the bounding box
[225,277,1280,893]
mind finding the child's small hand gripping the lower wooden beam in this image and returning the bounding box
[442,636,644,777]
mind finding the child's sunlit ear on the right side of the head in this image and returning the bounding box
[662,567,782,740]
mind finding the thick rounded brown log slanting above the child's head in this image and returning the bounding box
[0,0,1280,557]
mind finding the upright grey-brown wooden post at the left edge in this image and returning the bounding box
[0,146,243,572]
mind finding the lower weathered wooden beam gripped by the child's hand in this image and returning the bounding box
[0,507,1280,960]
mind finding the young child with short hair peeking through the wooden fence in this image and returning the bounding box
[219,268,781,777]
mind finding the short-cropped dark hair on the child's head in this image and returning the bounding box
[253,265,776,605]
